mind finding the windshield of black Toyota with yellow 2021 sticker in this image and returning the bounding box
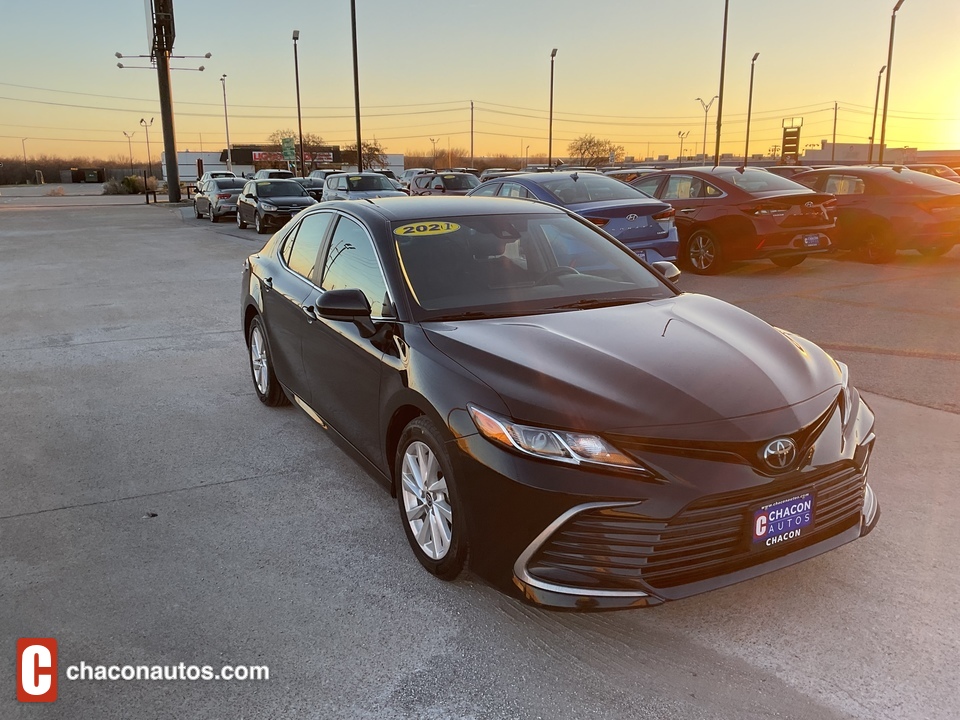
[393,211,675,320]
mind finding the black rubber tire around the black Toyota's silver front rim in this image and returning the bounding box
[394,416,468,580]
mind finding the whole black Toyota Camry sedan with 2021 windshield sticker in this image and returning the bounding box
[241,197,879,609]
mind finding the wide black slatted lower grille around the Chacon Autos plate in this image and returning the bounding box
[527,467,864,590]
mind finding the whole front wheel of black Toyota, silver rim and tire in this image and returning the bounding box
[394,416,468,580]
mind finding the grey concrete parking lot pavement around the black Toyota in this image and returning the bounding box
[0,197,960,720]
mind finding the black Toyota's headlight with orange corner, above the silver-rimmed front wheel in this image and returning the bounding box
[467,405,653,476]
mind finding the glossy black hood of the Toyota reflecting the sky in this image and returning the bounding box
[424,294,840,440]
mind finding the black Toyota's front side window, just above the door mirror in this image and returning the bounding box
[320,217,389,317]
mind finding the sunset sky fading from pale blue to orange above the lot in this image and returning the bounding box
[0,0,960,161]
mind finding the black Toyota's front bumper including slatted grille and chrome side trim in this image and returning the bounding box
[458,394,880,610]
